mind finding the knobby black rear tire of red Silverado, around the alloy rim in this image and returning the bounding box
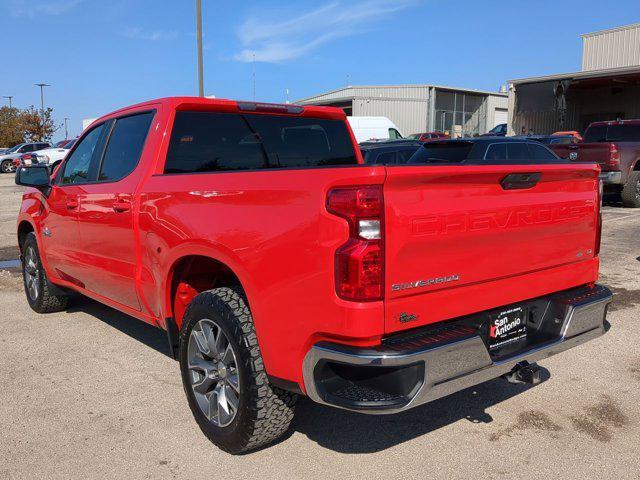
[179,287,297,454]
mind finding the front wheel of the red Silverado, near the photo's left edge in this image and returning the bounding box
[22,232,69,313]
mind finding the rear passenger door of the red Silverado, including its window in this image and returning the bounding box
[78,111,154,310]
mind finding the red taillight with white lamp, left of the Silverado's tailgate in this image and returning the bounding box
[327,185,384,302]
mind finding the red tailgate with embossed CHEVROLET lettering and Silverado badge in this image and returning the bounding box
[384,164,599,333]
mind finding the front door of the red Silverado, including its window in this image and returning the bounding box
[42,125,104,287]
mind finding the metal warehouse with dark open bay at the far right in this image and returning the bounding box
[509,24,640,134]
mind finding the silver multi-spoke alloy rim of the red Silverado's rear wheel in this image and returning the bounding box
[187,318,240,427]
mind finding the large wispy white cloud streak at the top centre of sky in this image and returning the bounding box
[234,0,415,63]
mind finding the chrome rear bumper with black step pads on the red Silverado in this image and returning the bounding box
[303,285,612,413]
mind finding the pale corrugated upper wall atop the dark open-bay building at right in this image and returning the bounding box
[582,24,640,71]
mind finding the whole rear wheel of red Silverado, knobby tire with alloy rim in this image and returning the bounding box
[180,288,297,454]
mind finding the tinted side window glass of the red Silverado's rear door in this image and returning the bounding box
[98,112,153,181]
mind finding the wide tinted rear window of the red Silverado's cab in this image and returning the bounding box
[165,112,358,173]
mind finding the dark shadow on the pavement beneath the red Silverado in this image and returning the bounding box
[68,296,550,454]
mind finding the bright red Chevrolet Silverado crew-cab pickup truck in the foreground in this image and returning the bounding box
[16,97,611,453]
